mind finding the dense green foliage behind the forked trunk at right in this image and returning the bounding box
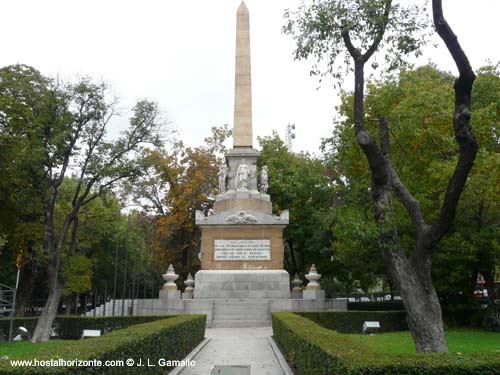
[332,65,500,324]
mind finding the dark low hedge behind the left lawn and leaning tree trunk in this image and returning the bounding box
[0,315,167,339]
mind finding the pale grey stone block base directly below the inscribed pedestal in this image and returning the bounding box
[194,270,290,299]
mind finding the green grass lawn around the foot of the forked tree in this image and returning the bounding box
[349,329,500,356]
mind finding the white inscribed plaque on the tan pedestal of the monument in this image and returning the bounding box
[214,240,271,260]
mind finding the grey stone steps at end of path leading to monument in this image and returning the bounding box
[212,299,271,327]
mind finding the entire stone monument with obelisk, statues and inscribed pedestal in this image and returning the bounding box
[194,2,290,299]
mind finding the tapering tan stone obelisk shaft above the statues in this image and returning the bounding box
[233,1,252,148]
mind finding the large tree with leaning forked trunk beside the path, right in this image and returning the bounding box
[287,0,478,352]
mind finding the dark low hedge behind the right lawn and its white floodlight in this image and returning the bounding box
[297,311,408,333]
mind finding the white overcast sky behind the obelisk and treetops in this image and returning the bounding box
[0,0,500,151]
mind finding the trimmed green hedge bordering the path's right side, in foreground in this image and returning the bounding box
[272,313,500,375]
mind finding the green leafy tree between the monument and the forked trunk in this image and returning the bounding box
[259,133,339,276]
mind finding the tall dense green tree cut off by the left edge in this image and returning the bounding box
[0,65,49,315]
